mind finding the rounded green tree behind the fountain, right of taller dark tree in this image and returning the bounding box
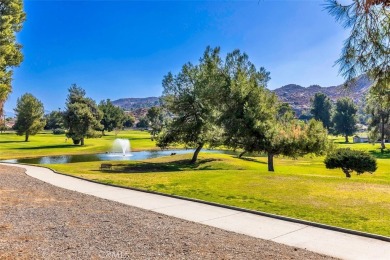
[99,99,125,135]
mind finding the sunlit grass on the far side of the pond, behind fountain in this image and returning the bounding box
[0,130,157,160]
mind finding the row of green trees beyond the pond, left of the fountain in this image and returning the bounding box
[14,84,135,142]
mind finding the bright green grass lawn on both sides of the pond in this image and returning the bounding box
[0,131,390,236]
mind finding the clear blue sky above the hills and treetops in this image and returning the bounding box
[5,0,348,115]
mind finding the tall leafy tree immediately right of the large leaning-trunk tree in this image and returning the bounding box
[215,50,277,156]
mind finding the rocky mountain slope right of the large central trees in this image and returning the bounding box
[273,75,372,116]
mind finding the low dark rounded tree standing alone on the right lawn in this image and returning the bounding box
[325,148,377,178]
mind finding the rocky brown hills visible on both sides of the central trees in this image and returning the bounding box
[112,75,372,118]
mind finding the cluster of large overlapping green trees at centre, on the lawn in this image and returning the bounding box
[157,47,328,171]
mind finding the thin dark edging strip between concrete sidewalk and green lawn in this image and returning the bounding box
[14,163,390,242]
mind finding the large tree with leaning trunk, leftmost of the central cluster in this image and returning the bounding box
[157,47,224,163]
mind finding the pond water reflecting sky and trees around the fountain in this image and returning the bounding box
[2,149,232,164]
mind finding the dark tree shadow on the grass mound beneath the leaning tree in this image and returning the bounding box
[94,159,218,173]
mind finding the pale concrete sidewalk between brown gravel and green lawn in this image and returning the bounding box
[4,164,390,260]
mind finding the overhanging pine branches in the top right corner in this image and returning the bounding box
[327,0,390,80]
